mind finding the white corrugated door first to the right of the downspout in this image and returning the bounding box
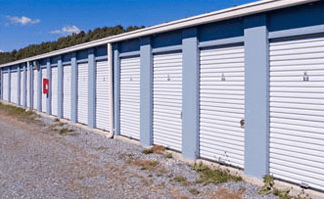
[120,57,140,139]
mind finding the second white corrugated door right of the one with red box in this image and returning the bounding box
[63,65,71,120]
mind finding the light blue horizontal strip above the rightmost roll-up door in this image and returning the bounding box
[269,25,324,39]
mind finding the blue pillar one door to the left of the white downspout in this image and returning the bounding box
[88,48,95,128]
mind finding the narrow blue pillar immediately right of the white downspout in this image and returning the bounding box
[113,44,120,136]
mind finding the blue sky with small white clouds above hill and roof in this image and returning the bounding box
[0,0,256,52]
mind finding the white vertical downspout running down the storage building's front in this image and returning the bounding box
[107,43,114,138]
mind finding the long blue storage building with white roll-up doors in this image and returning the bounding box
[0,0,324,191]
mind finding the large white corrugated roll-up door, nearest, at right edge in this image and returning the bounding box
[270,36,324,190]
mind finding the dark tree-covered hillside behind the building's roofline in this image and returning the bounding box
[0,25,145,64]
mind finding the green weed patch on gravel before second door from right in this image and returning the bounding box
[192,163,242,185]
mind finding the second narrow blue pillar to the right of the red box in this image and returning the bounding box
[57,56,63,119]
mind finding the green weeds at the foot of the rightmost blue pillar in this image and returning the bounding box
[257,175,307,199]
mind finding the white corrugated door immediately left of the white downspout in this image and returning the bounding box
[96,61,110,130]
